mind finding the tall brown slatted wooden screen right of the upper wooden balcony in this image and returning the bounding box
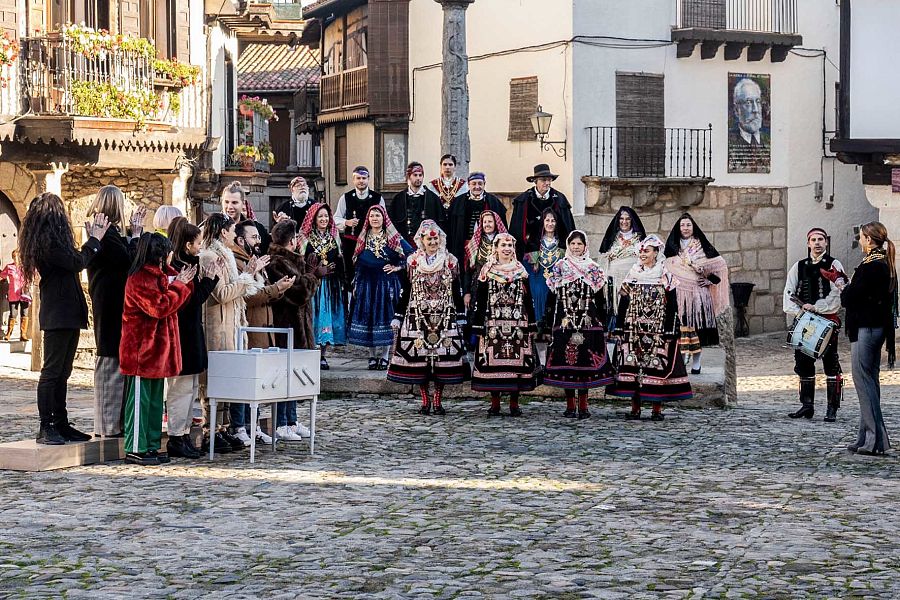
[368,0,417,117]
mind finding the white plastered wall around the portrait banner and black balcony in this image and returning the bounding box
[570,0,875,264]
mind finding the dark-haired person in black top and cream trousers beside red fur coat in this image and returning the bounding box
[166,217,218,458]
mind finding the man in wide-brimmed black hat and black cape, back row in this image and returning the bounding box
[509,165,575,258]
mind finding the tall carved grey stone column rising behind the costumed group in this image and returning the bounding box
[435,0,475,177]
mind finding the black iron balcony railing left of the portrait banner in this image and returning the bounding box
[587,125,712,179]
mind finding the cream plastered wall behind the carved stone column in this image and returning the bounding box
[409,0,574,197]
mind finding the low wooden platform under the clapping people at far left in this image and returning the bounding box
[0,438,126,471]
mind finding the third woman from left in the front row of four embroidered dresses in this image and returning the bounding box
[544,230,614,419]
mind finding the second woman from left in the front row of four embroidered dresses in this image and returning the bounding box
[472,233,541,417]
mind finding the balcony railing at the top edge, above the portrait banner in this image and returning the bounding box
[675,0,797,34]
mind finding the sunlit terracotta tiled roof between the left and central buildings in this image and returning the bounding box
[238,44,320,92]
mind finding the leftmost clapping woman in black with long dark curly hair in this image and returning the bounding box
[19,192,109,445]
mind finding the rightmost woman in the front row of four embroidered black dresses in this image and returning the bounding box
[607,234,693,421]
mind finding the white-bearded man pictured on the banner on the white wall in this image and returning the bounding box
[728,77,771,172]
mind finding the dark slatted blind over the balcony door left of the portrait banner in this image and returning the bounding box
[616,73,666,177]
